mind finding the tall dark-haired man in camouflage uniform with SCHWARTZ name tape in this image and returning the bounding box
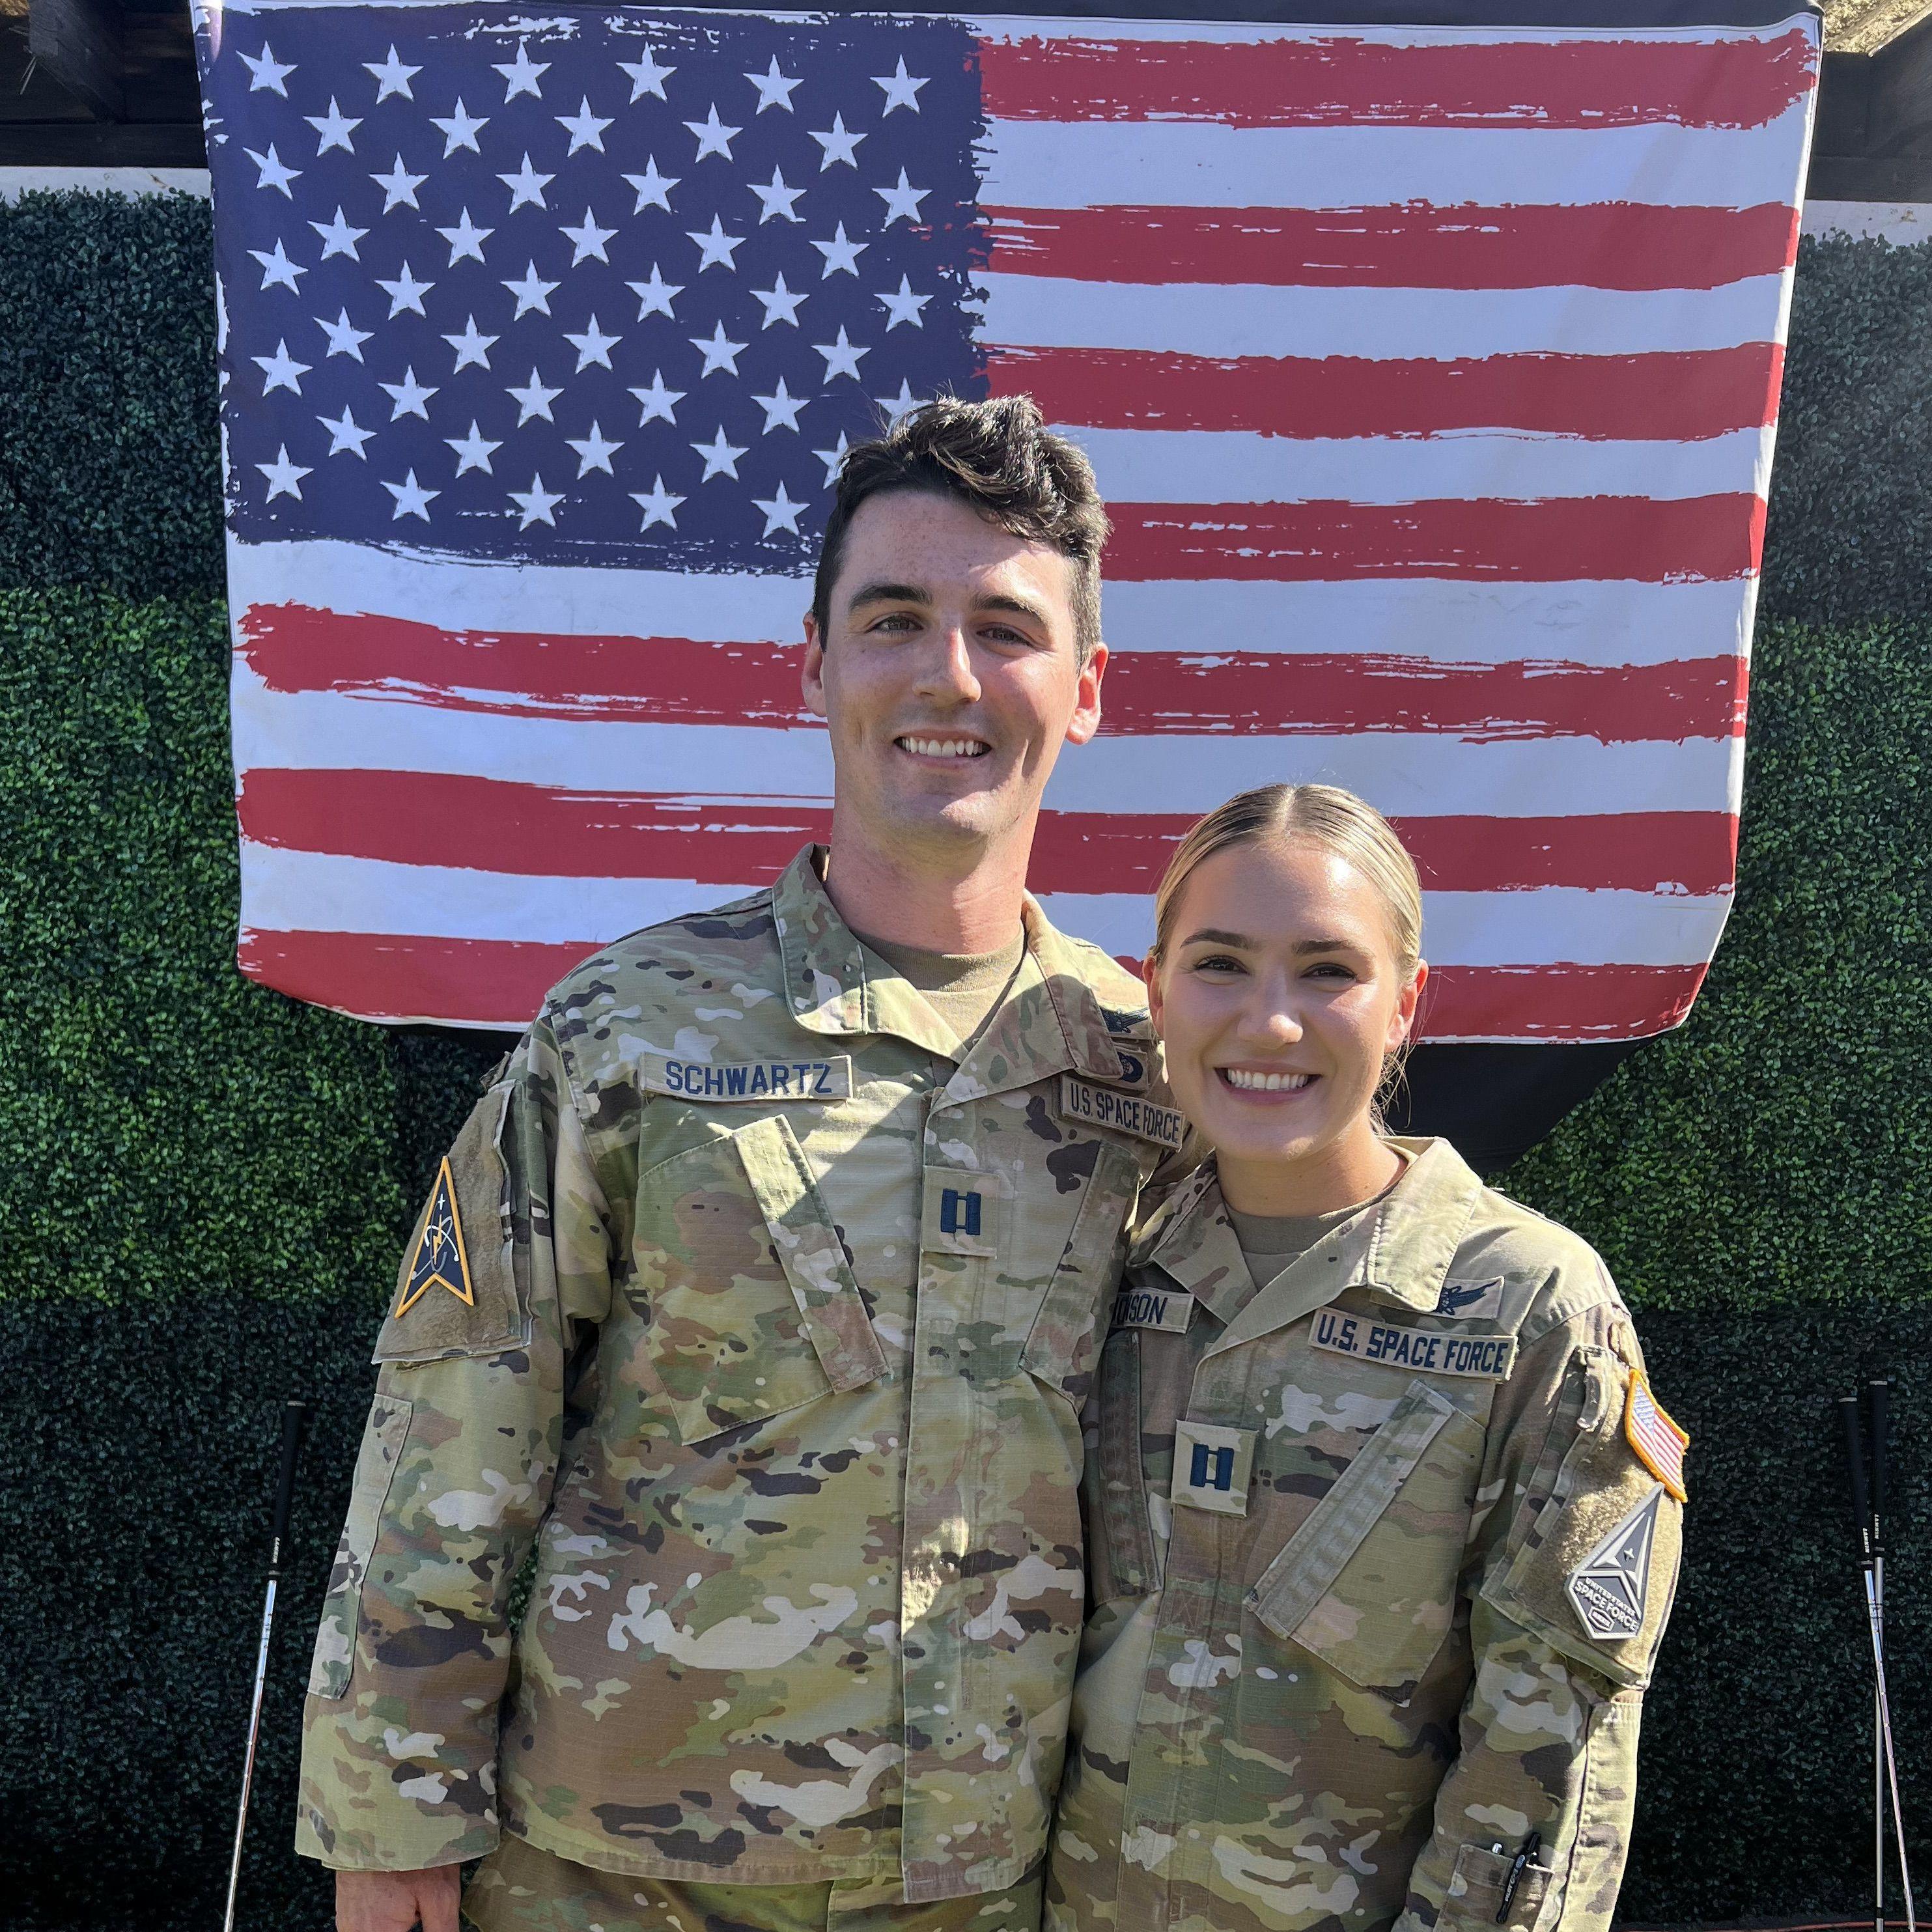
[298,402,1179,1932]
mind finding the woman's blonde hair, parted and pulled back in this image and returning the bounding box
[1153,785,1422,1127]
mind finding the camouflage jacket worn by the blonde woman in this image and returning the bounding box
[1049,1141,1683,1932]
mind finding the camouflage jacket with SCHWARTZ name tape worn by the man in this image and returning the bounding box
[298,852,1179,1899]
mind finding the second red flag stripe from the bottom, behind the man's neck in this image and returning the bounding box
[238,767,1737,895]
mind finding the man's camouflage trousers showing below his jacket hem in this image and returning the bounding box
[464,1836,1043,1932]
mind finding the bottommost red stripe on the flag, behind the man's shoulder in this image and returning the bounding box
[238,927,1704,1041]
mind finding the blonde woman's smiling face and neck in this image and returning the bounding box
[1147,833,1428,1213]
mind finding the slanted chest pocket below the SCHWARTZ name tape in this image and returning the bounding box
[636,1115,885,1443]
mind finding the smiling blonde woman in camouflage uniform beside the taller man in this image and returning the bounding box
[1047,785,1685,1932]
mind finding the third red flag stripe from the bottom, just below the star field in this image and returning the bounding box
[242,605,1744,744]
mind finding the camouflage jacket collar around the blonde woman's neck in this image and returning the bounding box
[1136,1140,1482,1354]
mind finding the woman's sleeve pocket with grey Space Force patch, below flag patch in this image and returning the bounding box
[1482,1351,1683,1690]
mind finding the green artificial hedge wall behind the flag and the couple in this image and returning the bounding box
[0,195,1932,1932]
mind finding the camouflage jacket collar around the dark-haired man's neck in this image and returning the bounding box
[771,847,1123,1099]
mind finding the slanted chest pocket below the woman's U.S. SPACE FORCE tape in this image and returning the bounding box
[1248,1381,1484,1702]
